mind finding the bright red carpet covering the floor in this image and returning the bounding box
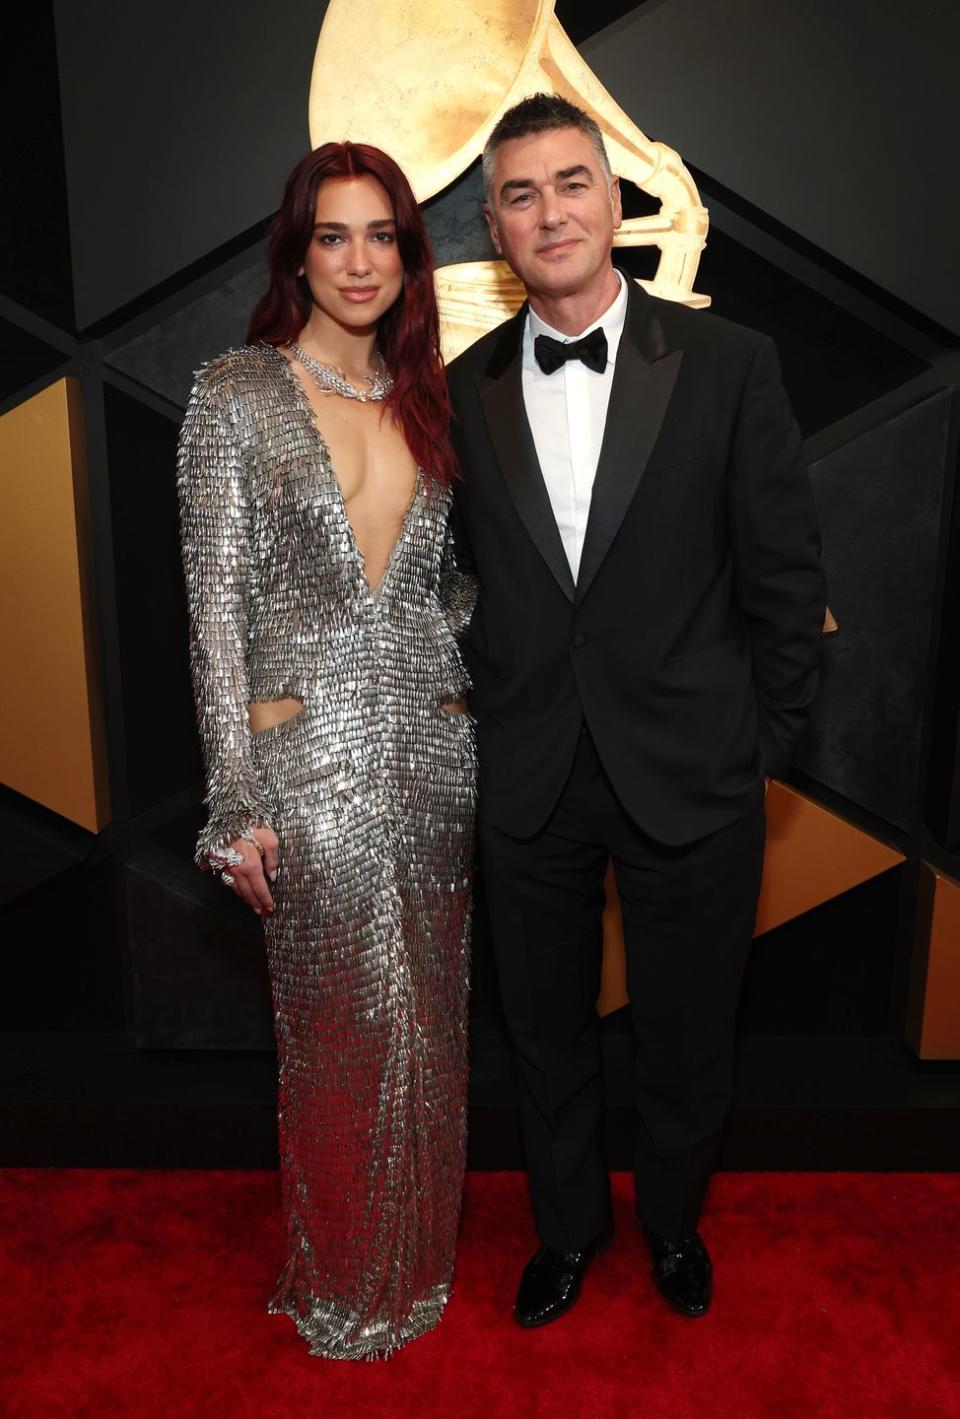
[0,1169,960,1419]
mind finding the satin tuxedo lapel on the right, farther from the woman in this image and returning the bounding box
[577,305,683,602]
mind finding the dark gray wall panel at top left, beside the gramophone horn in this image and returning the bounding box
[55,0,326,329]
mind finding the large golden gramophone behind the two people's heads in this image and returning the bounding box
[309,0,710,359]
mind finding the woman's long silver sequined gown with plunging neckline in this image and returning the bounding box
[179,345,475,1358]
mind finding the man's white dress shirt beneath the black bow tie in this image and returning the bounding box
[522,271,627,582]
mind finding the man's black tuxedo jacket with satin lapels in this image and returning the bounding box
[448,281,825,844]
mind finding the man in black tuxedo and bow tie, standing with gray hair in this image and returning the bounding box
[450,95,825,1325]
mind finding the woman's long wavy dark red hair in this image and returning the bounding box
[247,143,458,484]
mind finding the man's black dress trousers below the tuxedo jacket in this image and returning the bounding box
[479,734,766,1252]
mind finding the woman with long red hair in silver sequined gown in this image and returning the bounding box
[179,143,475,1358]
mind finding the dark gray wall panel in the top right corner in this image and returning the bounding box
[583,0,960,331]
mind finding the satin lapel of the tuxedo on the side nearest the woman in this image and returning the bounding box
[478,340,574,602]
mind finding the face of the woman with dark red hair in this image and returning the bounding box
[298,173,403,331]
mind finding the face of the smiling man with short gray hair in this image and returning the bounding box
[484,128,623,299]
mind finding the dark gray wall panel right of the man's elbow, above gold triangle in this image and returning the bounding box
[794,390,959,830]
